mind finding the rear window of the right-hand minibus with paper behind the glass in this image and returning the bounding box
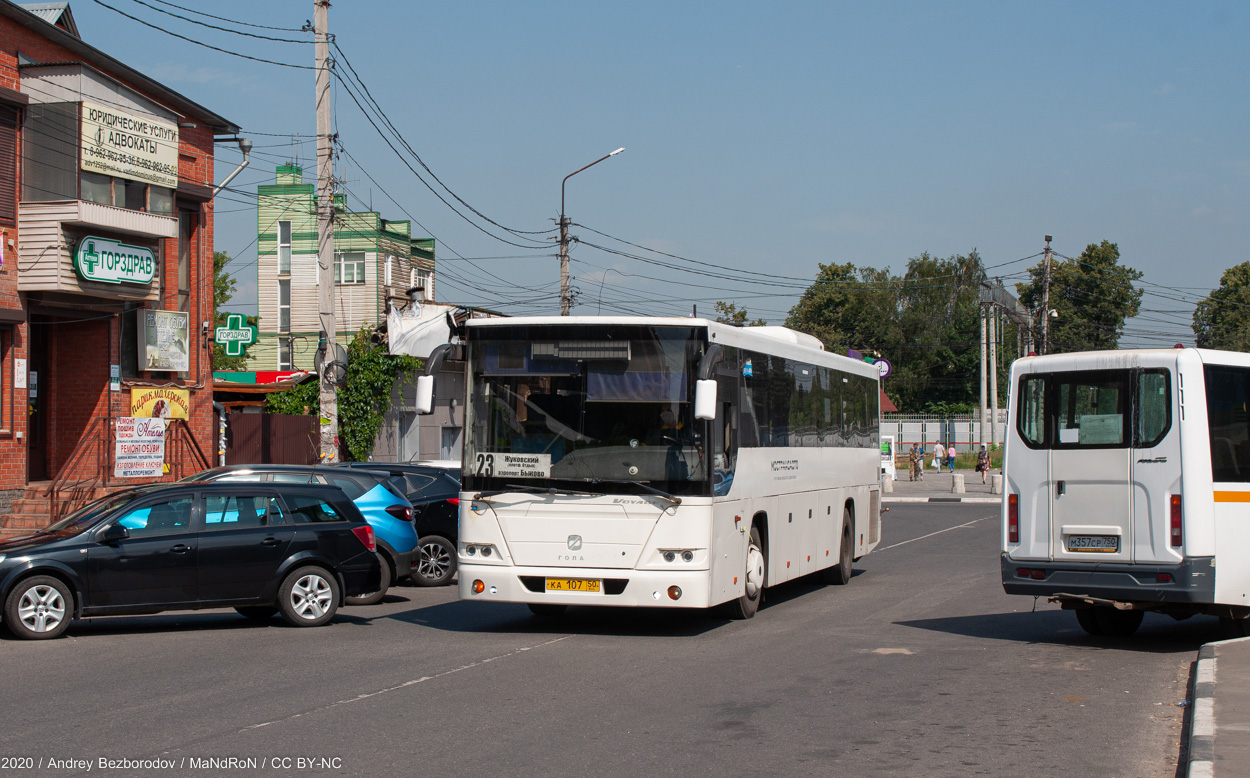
[1053,370,1129,448]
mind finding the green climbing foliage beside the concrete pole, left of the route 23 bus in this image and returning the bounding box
[266,326,421,462]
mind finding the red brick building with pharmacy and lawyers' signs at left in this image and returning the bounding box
[0,0,239,534]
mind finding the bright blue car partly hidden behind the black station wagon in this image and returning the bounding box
[184,464,420,605]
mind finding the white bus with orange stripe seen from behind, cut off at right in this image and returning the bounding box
[1001,348,1250,635]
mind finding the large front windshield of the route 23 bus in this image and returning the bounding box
[464,324,711,495]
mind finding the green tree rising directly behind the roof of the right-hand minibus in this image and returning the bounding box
[1016,240,1141,354]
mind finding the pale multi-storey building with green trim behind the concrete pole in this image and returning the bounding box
[248,165,434,370]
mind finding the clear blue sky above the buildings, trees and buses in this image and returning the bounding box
[73,0,1250,345]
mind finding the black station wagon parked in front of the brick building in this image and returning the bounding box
[0,483,381,639]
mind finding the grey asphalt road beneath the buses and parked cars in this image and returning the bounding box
[0,504,1220,778]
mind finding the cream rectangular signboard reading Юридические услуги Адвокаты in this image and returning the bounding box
[83,100,178,189]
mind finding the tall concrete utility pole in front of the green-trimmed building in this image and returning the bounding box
[313,0,339,464]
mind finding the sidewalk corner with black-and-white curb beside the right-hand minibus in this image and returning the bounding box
[1189,638,1250,778]
